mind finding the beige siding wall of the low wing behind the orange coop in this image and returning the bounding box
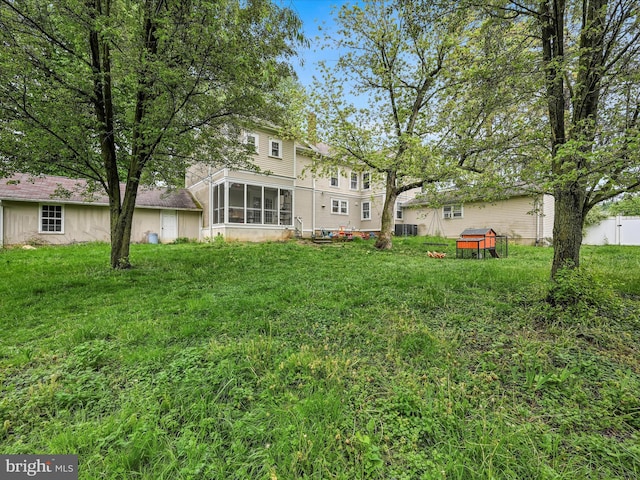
[404,196,553,245]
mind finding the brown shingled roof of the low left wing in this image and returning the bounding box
[0,173,202,210]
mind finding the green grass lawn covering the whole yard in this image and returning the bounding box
[0,238,640,480]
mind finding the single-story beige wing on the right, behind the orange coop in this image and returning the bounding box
[402,189,554,245]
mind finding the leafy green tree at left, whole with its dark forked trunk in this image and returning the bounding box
[0,0,303,268]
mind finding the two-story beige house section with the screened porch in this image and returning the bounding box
[186,127,398,241]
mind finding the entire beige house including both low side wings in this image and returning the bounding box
[0,126,553,245]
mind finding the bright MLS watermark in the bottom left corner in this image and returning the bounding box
[0,455,78,480]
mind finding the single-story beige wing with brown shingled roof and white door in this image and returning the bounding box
[0,174,202,247]
